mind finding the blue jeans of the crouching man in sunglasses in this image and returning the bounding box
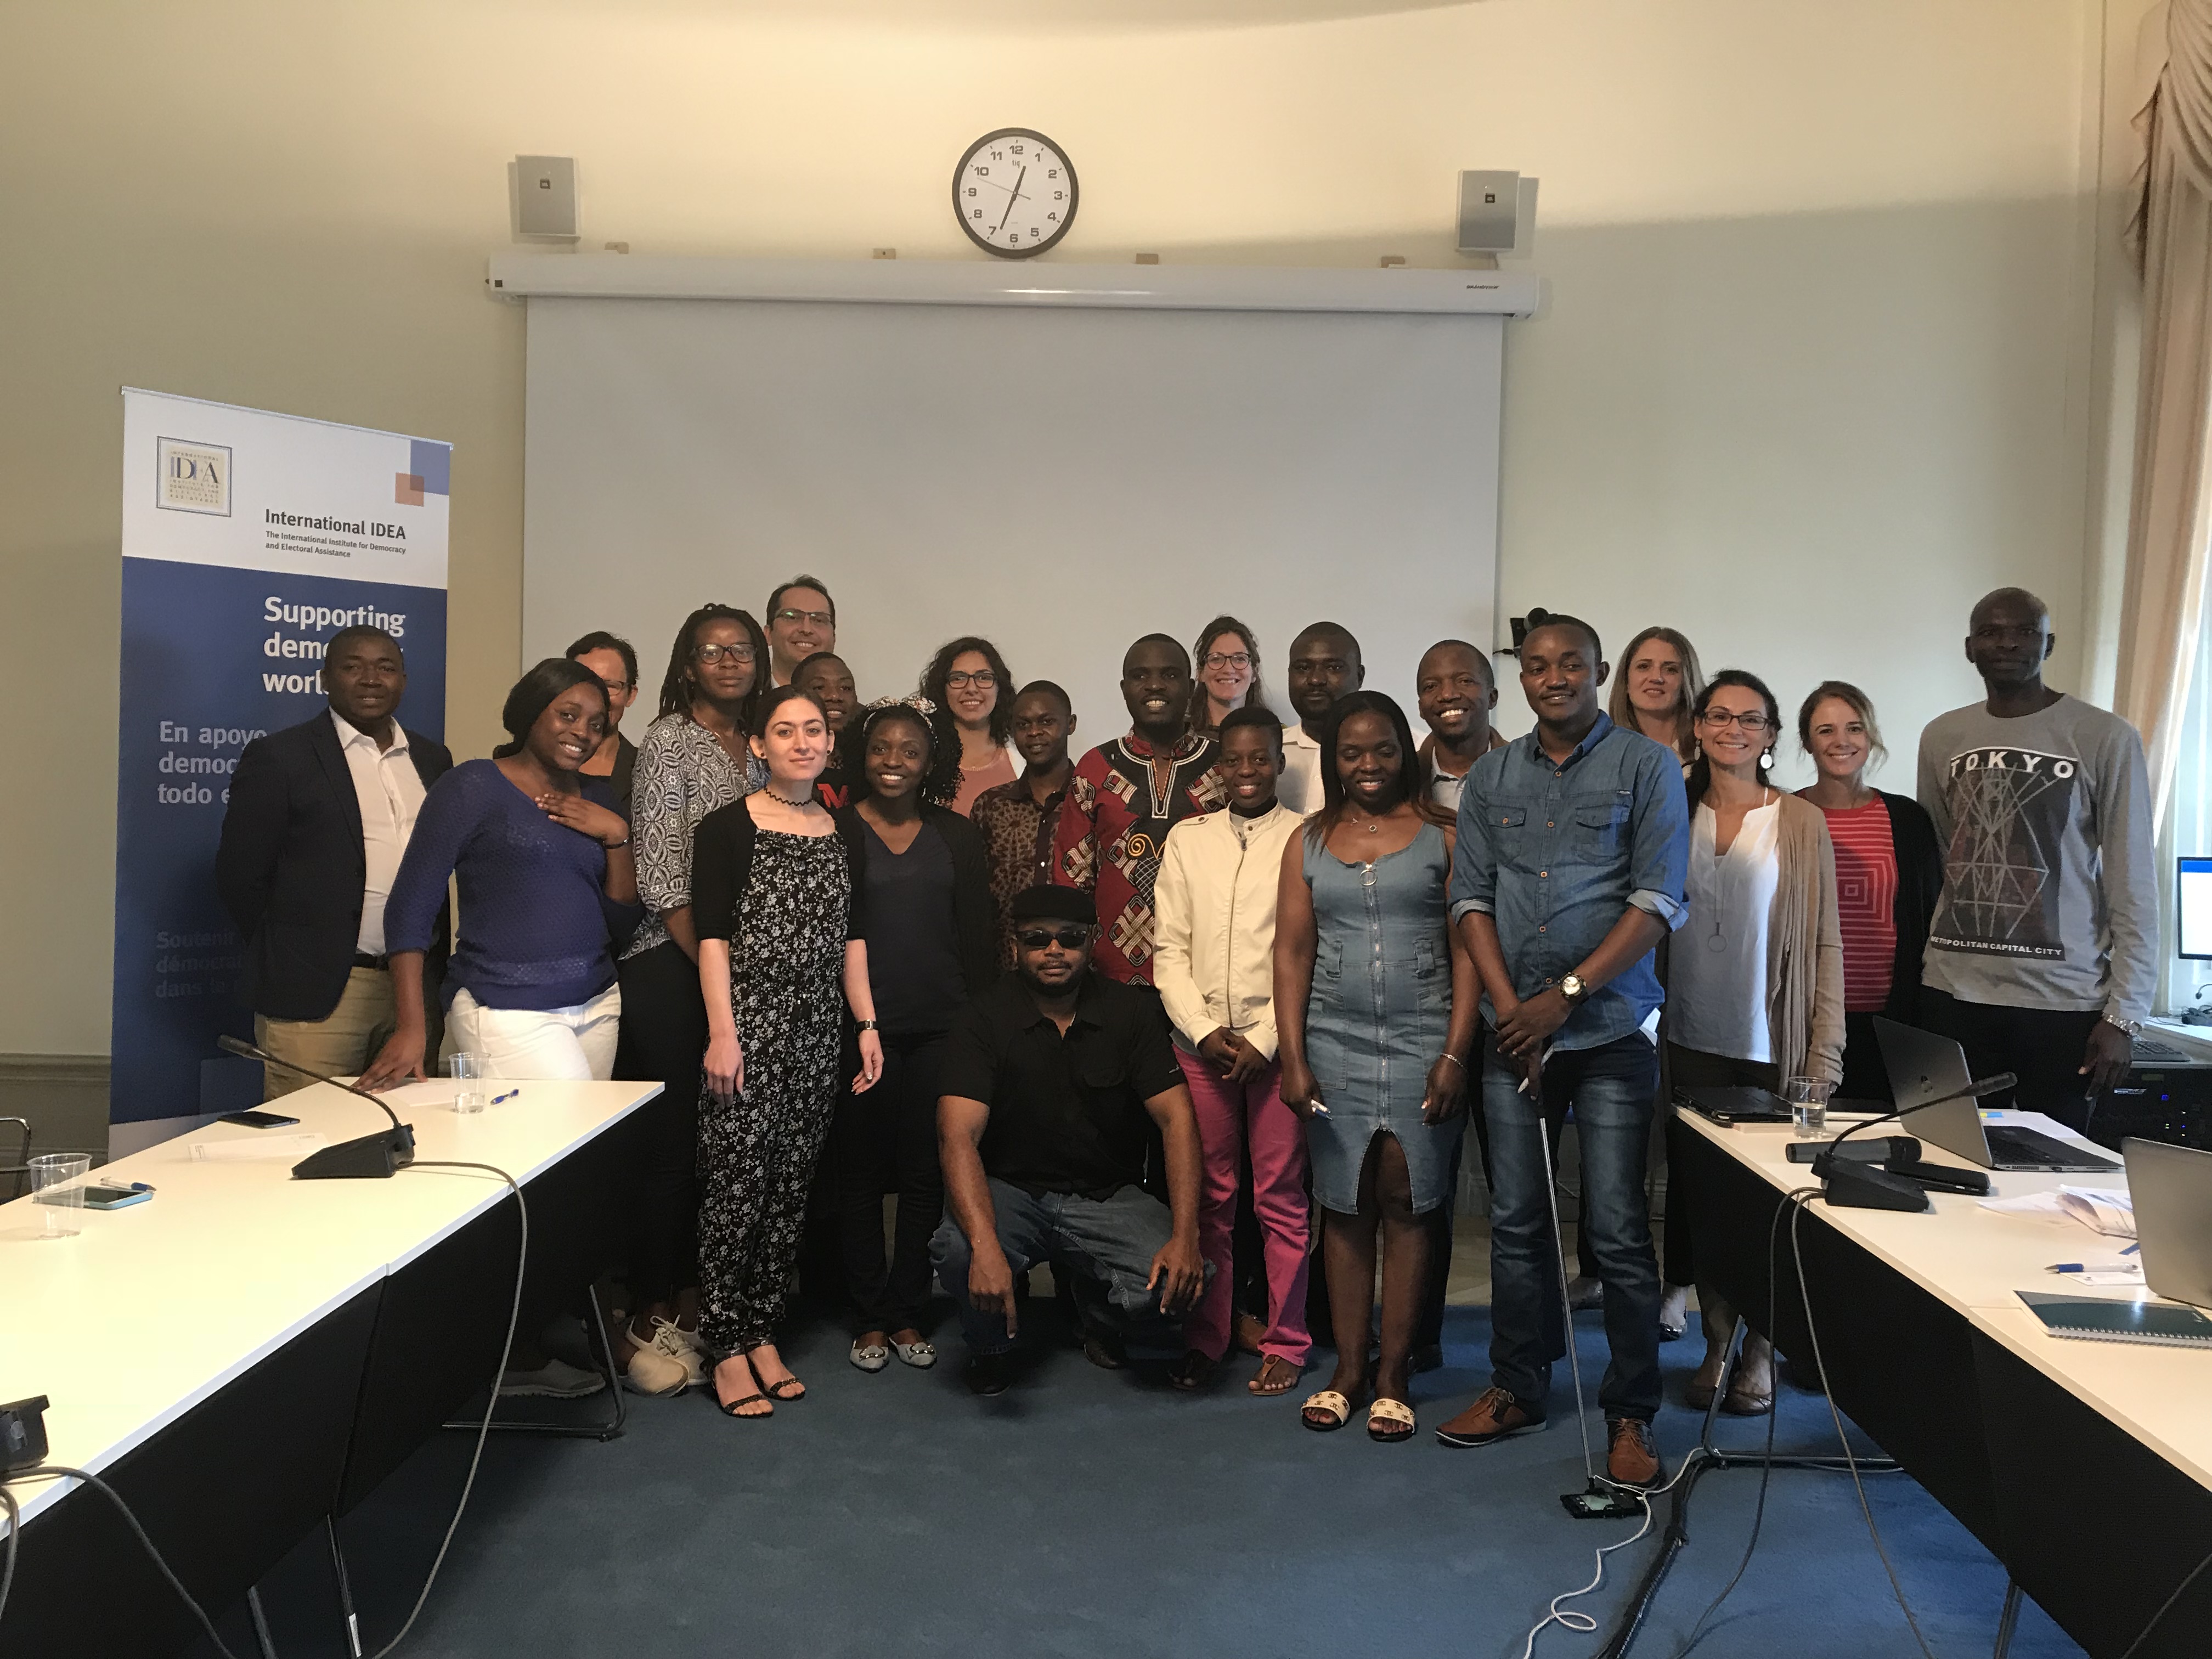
[929,1177,1183,1354]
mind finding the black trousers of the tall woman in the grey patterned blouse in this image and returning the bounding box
[615,940,706,1307]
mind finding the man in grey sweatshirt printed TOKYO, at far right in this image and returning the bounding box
[1920,589,2159,1130]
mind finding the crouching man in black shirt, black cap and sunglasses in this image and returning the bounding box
[929,887,1205,1393]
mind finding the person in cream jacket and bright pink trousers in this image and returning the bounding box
[1153,708,1312,1393]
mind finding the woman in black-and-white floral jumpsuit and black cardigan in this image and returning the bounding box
[692,686,883,1418]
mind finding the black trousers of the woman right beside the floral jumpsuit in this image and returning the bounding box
[830,1033,947,1331]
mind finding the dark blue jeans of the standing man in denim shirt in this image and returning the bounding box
[1482,1031,1659,1423]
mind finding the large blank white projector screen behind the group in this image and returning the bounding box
[522,296,1504,750]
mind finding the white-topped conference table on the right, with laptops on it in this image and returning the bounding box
[1670,1113,2212,1659]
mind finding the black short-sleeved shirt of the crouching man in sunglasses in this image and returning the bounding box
[938,973,1183,1199]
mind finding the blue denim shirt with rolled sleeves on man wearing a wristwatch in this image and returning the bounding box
[1451,714,1690,1048]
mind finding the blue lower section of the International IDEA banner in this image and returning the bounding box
[111,562,444,1124]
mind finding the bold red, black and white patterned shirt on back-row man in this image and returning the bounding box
[1053,732,1230,984]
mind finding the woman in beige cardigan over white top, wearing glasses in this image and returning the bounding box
[1666,668,1843,1415]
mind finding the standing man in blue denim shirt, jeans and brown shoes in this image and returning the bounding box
[1436,615,1690,1487]
